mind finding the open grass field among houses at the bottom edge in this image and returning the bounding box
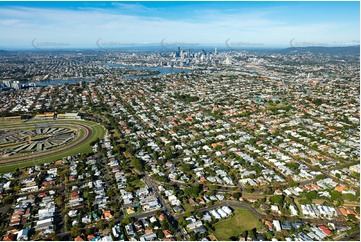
[214,207,262,240]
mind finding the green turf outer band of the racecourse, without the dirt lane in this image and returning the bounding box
[0,120,105,173]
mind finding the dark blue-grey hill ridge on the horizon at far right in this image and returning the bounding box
[281,45,360,55]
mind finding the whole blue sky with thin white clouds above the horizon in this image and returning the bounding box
[0,1,360,49]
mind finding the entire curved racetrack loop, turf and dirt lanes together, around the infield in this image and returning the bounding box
[0,120,106,173]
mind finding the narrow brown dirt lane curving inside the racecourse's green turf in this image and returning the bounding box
[0,123,93,164]
